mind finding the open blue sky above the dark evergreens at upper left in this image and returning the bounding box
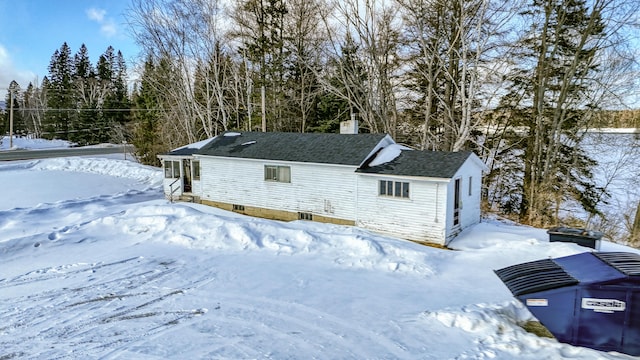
[0,0,138,90]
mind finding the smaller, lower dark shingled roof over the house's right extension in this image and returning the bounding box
[357,150,471,179]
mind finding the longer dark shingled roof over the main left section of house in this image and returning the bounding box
[196,132,386,166]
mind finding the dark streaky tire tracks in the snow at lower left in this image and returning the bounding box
[0,257,212,359]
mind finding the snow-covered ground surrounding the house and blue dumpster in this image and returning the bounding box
[0,137,634,359]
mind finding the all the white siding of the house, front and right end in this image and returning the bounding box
[182,146,484,245]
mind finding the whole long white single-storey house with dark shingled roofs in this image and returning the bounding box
[160,132,486,245]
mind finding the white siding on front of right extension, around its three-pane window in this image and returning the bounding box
[356,174,447,244]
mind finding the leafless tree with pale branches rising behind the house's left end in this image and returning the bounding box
[129,0,233,142]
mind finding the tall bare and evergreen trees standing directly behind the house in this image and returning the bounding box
[3,0,640,242]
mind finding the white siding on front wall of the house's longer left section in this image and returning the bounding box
[199,156,356,220]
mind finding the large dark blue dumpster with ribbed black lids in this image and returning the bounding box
[495,252,640,356]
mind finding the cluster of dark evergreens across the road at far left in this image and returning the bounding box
[3,42,131,145]
